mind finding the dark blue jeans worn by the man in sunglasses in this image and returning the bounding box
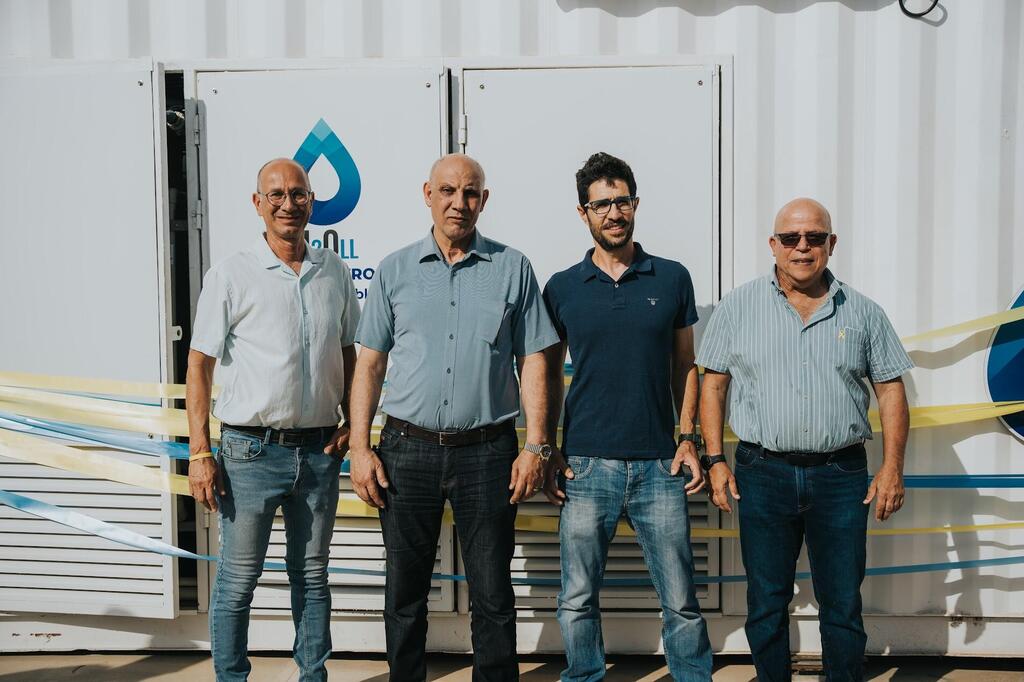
[735,444,867,682]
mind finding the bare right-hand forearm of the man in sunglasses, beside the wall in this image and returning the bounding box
[864,377,910,521]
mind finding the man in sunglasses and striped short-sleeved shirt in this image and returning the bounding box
[696,199,912,681]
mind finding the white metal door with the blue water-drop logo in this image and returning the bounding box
[197,65,455,613]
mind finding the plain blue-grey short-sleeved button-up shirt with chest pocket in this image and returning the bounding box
[355,230,558,430]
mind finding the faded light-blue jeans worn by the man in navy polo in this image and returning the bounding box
[558,456,712,682]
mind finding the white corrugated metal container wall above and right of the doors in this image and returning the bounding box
[0,0,1024,615]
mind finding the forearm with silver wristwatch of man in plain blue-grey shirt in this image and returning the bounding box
[509,350,551,505]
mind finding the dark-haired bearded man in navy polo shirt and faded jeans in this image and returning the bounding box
[544,153,712,681]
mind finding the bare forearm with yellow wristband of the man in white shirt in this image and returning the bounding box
[185,349,224,511]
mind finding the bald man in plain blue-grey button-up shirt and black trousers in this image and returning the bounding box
[351,155,558,680]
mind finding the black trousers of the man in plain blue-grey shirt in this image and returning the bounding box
[378,419,519,682]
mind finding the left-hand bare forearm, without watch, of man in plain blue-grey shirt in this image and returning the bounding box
[348,346,388,509]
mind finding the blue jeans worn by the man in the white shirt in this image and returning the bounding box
[210,429,341,682]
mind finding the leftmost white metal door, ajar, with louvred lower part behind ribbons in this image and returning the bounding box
[0,61,178,617]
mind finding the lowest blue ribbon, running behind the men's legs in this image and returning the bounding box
[0,491,1024,587]
